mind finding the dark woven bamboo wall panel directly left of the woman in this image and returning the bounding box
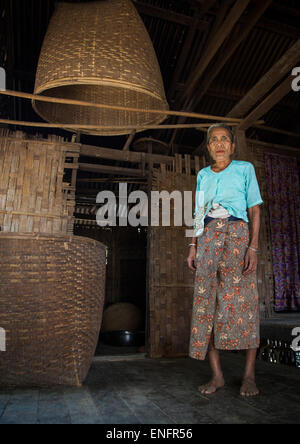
[149,156,204,357]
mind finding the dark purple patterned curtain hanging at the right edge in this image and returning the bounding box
[265,153,300,311]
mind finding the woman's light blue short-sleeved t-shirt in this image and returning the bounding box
[194,160,263,229]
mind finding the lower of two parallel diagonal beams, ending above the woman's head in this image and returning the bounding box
[237,76,294,130]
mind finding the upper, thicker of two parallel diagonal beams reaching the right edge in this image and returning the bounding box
[227,39,300,117]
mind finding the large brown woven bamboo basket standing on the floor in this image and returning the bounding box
[0,233,106,386]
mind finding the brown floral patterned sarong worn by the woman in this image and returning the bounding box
[189,218,259,360]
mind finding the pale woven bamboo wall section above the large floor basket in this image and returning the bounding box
[0,130,79,234]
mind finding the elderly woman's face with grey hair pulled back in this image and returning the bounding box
[207,128,235,162]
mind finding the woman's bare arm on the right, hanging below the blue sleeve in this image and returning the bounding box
[243,205,260,276]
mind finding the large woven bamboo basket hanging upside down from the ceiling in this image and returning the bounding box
[33,0,168,135]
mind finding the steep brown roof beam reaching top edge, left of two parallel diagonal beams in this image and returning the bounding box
[185,0,251,99]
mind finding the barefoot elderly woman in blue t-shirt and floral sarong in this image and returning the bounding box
[188,123,263,396]
